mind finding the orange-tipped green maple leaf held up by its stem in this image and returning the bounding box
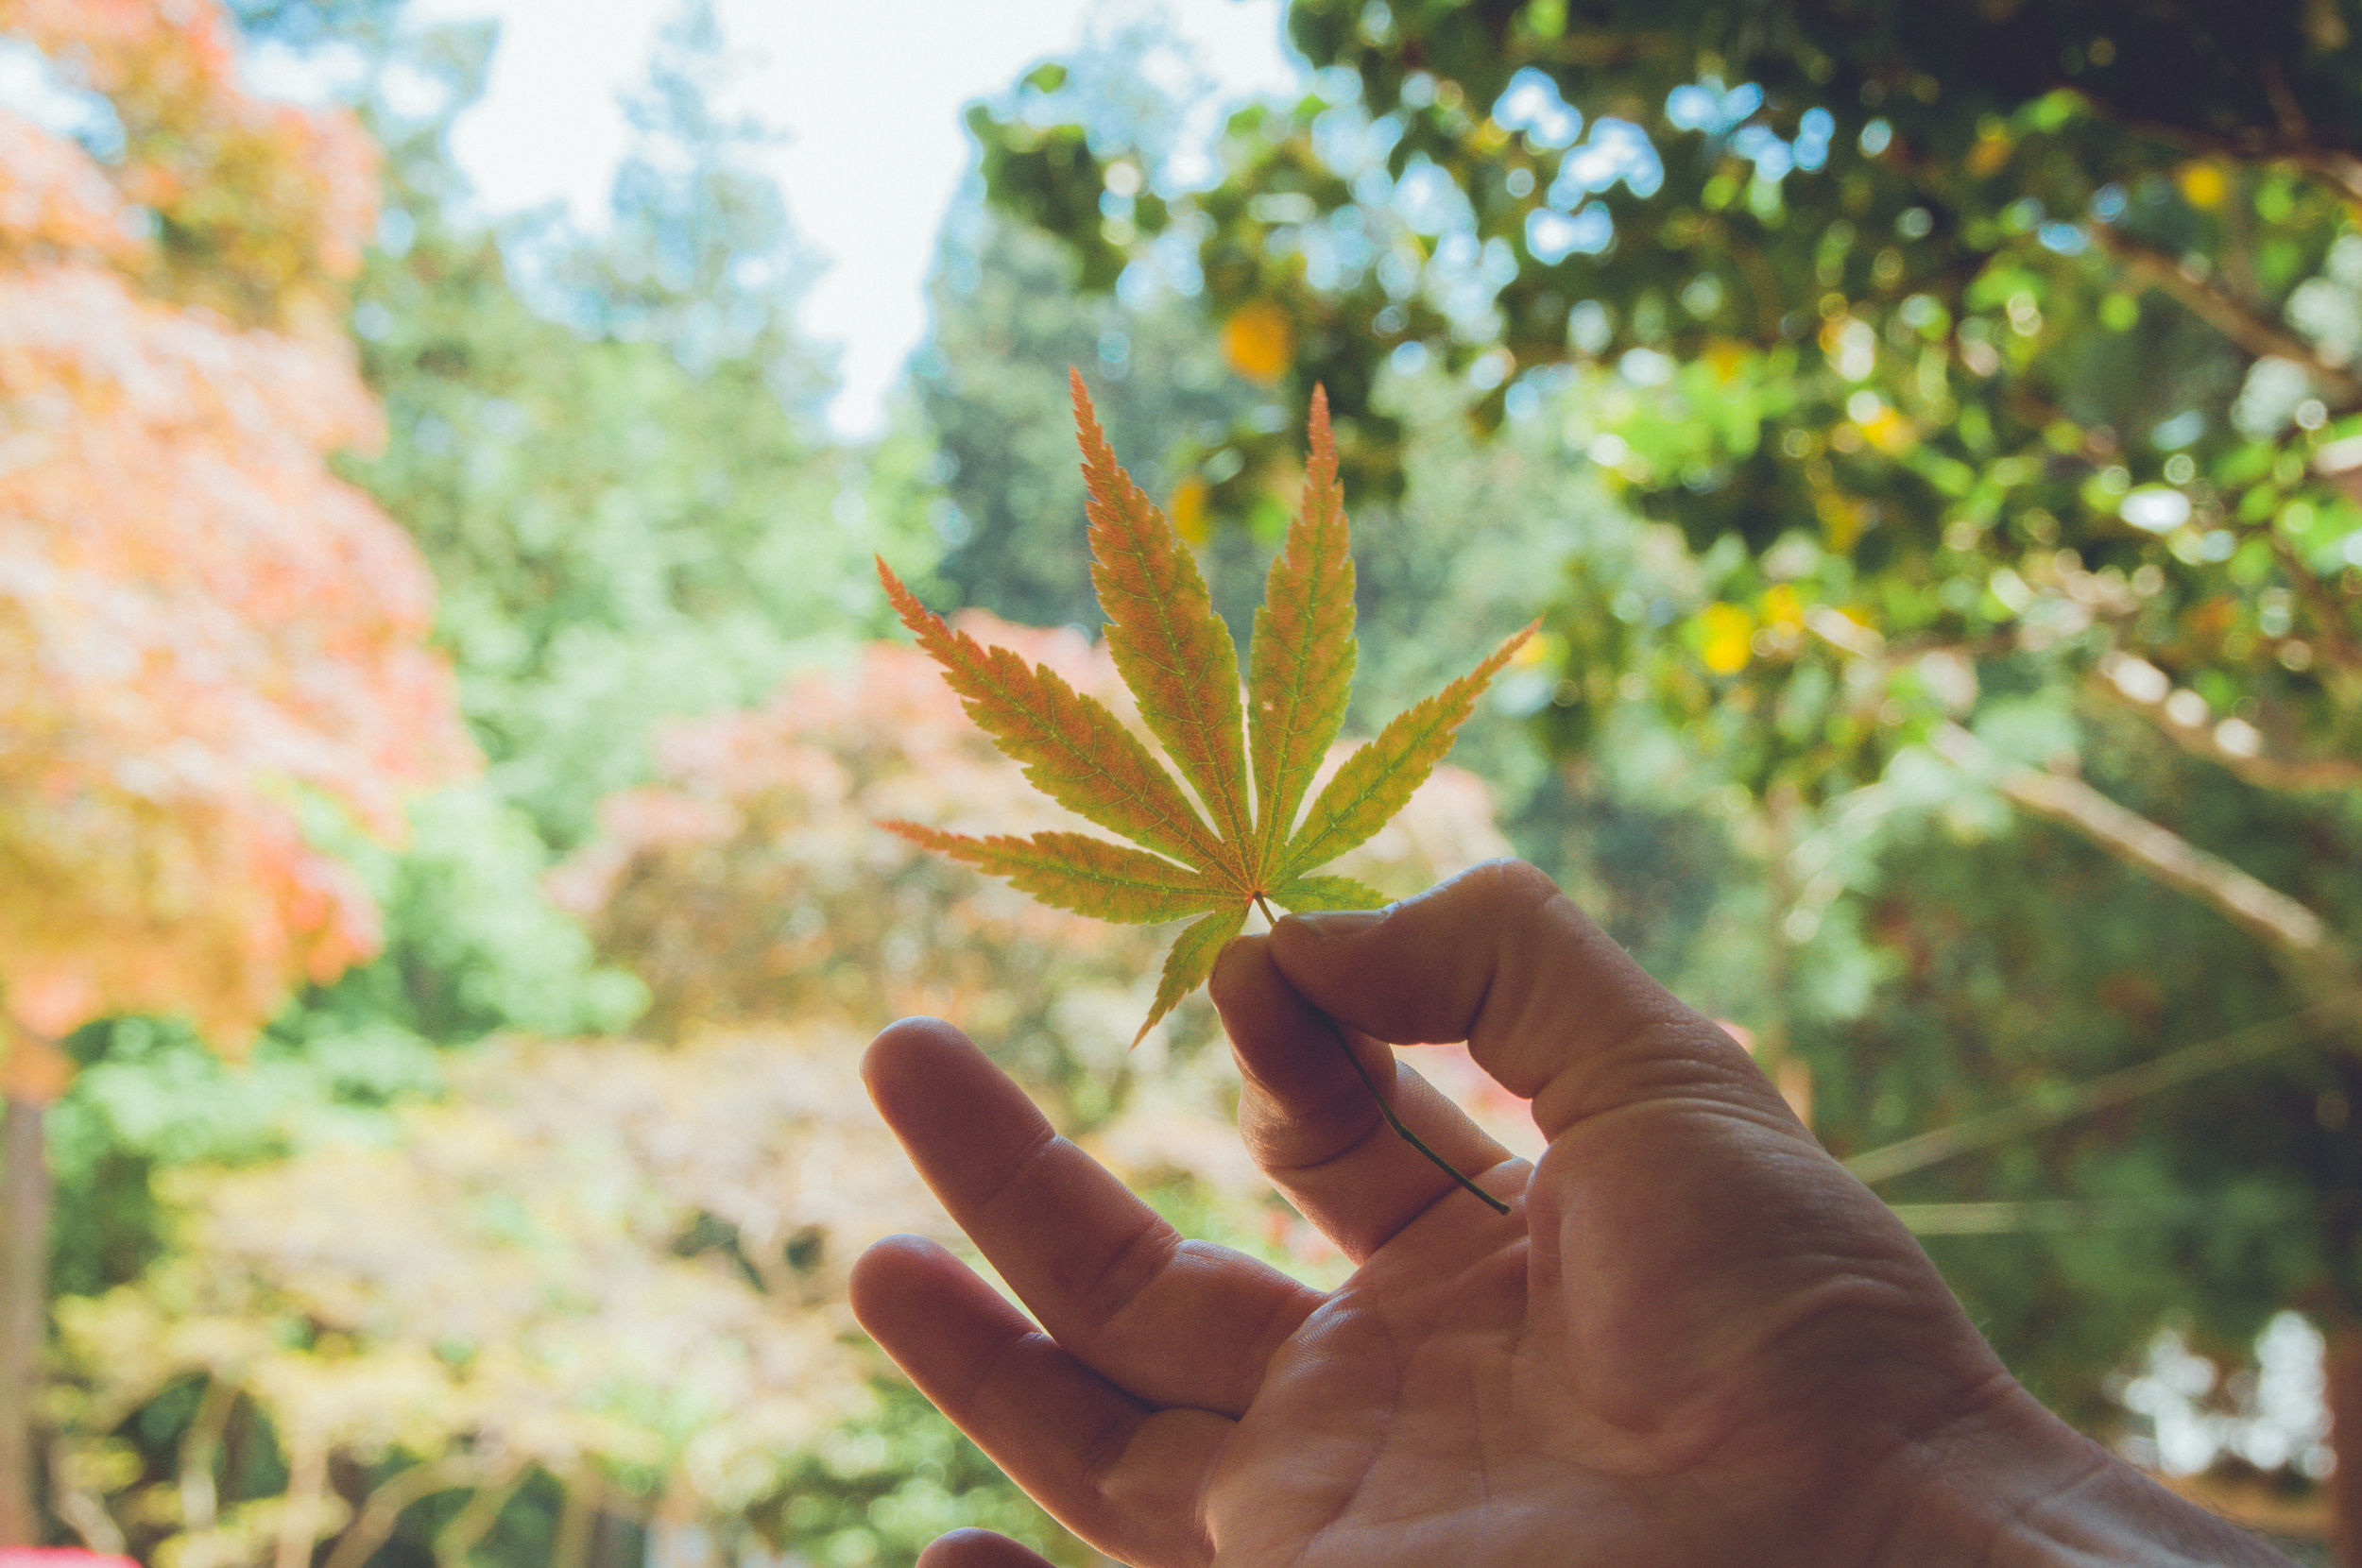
[879,373,1533,1044]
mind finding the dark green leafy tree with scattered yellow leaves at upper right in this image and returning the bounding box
[978,0,2362,1557]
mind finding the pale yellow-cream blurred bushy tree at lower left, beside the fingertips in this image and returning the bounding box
[43,1025,940,1568]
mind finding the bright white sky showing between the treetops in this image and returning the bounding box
[414,0,1299,439]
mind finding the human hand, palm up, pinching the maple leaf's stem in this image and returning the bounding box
[853,862,2280,1568]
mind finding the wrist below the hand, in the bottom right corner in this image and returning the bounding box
[1866,1382,2291,1568]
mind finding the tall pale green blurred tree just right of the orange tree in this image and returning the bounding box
[352,9,924,853]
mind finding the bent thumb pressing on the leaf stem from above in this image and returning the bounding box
[1271,860,1803,1138]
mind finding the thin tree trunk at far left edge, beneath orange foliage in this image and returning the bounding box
[0,1099,50,1547]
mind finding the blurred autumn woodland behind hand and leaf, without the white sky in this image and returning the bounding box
[0,0,2362,1568]
